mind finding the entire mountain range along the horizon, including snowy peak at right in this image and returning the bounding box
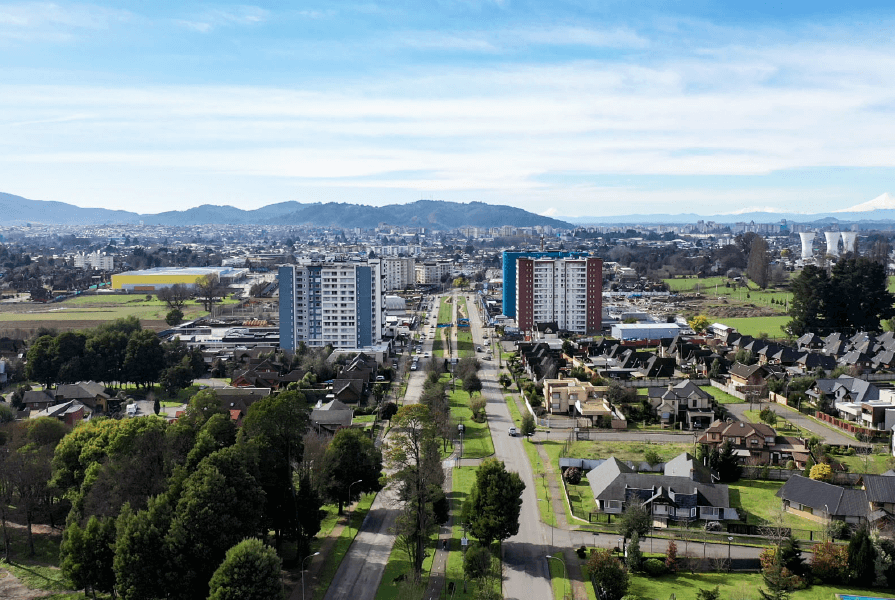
[0,192,895,230]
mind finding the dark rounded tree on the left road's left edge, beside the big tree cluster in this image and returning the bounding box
[321,429,382,515]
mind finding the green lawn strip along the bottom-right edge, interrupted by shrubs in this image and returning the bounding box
[628,573,888,600]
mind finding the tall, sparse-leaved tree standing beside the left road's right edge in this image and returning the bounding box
[385,404,444,579]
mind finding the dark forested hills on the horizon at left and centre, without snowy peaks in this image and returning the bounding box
[0,193,572,230]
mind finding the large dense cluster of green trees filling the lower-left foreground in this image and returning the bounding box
[49,390,323,599]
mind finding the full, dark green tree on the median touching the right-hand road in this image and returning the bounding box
[462,458,525,546]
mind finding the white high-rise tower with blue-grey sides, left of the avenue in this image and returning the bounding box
[277,259,385,350]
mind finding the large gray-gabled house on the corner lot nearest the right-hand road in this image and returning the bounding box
[587,453,739,526]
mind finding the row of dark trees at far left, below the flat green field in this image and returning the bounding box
[25,316,205,391]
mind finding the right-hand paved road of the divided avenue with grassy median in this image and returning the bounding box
[466,301,553,599]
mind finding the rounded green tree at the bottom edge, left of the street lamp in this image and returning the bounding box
[208,538,283,600]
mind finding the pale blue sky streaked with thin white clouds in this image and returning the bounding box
[0,0,895,218]
